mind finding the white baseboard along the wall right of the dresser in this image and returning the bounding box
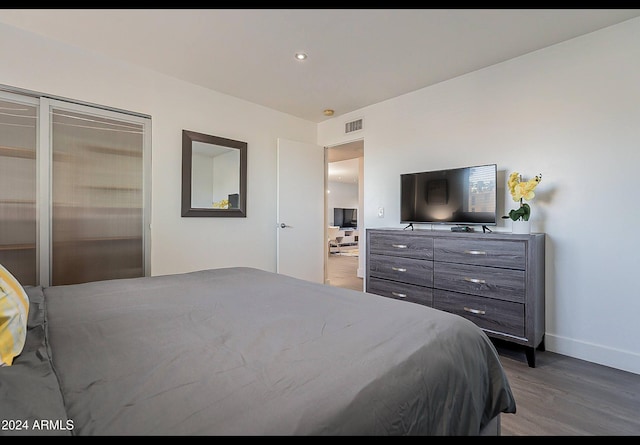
[544,333,640,374]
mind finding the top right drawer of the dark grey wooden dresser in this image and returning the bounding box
[433,238,527,270]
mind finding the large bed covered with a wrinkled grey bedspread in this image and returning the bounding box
[0,267,516,436]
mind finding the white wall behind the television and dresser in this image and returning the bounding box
[318,19,640,373]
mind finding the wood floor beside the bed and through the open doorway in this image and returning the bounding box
[328,255,640,436]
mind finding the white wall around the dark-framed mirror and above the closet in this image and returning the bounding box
[0,24,317,275]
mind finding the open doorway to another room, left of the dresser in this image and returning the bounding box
[325,140,364,291]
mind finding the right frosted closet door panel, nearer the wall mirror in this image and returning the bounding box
[48,101,149,285]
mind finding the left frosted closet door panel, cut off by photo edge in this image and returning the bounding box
[0,93,38,285]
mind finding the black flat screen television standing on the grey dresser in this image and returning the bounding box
[400,164,498,226]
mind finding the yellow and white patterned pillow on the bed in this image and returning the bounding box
[0,264,29,366]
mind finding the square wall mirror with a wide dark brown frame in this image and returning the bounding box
[182,130,247,217]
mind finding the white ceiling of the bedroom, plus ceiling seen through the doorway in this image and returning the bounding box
[0,8,640,182]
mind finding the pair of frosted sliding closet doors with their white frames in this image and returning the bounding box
[0,90,151,286]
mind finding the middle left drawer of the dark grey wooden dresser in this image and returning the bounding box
[368,254,433,286]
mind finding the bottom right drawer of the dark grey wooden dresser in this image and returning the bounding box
[433,289,525,338]
